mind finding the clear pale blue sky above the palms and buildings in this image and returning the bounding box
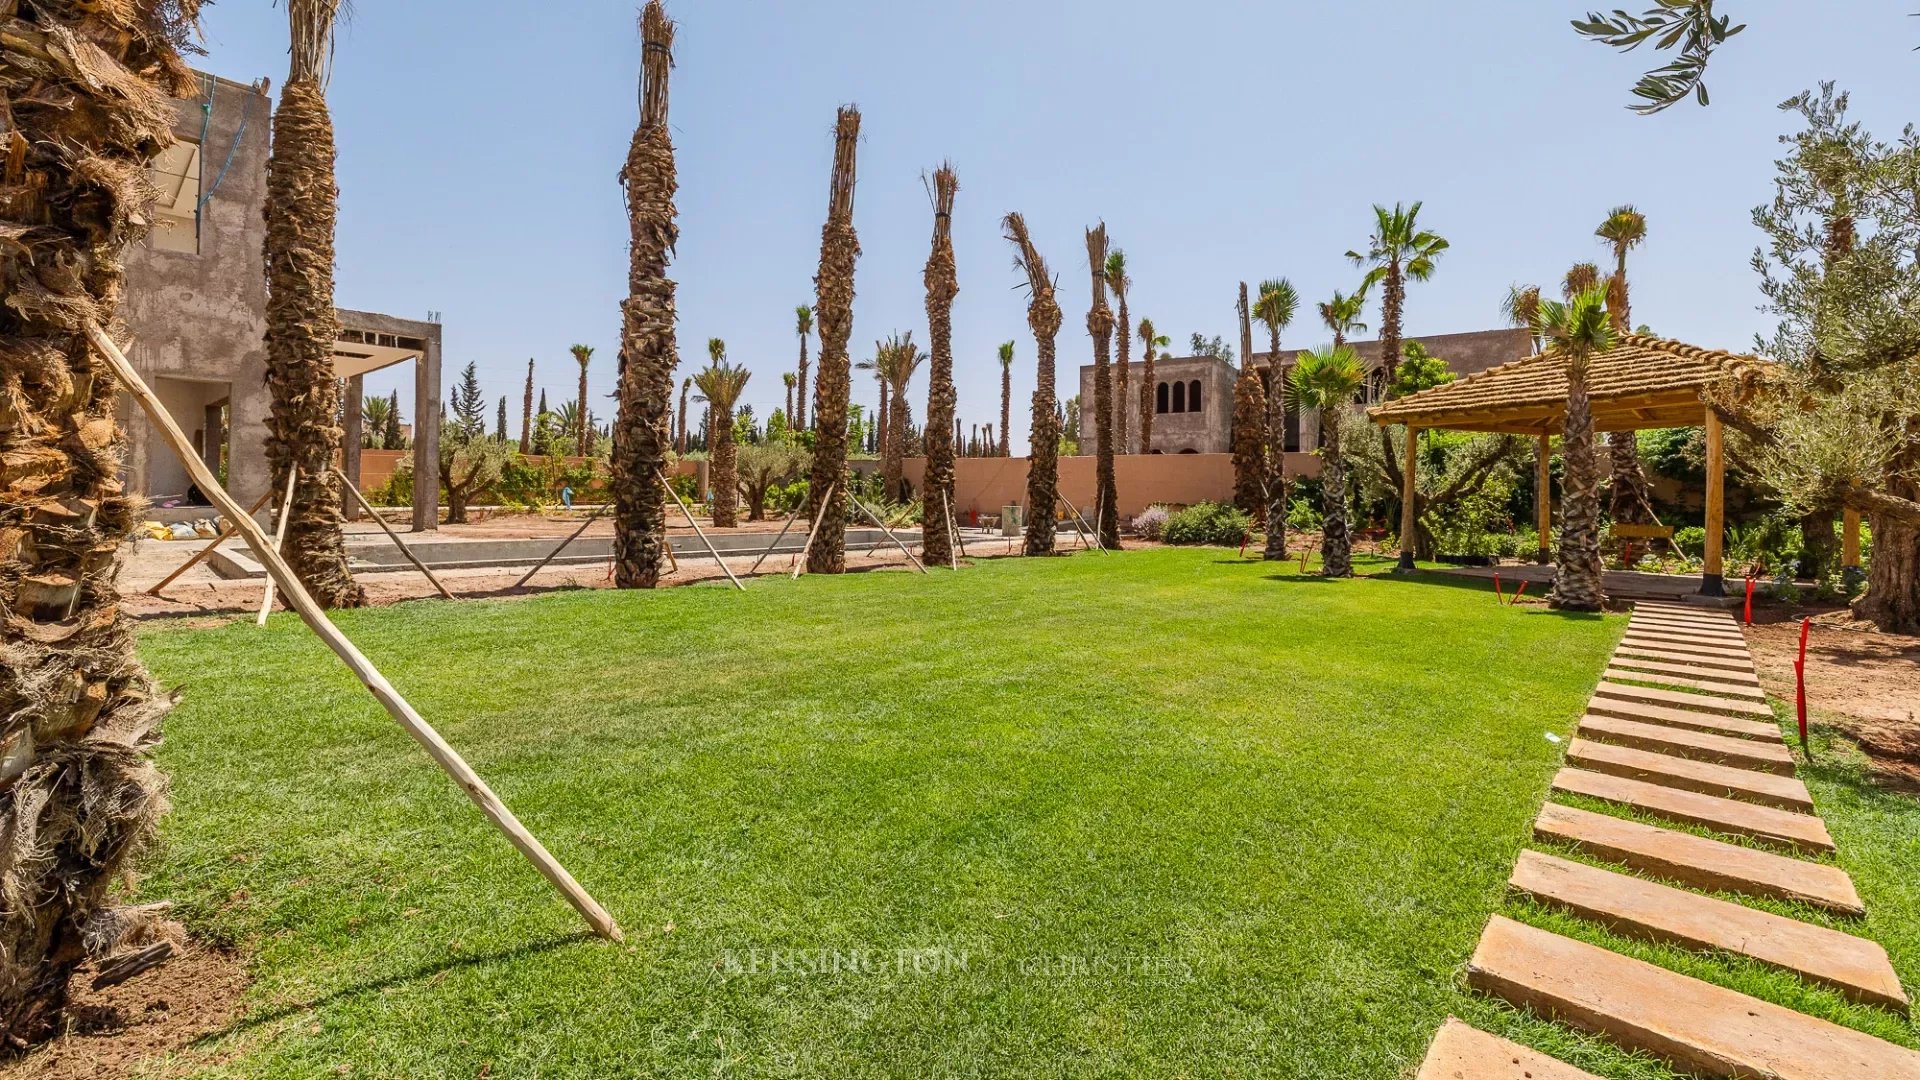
[183,0,1920,442]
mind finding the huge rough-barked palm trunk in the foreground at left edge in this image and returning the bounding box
[0,0,202,1045]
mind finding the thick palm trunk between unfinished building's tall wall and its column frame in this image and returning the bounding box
[265,0,367,607]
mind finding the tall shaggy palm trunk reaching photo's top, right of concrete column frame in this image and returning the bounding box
[611,0,680,588]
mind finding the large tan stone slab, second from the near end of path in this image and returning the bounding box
[1467,915,1920,1080]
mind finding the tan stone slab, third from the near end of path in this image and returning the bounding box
[1507,851,1907,1015]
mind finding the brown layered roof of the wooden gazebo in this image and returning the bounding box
[1367,334,1772,434]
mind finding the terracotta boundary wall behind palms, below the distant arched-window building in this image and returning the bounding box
[906,454,1319,517]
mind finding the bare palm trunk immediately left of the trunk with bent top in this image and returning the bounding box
[920,161,960,565]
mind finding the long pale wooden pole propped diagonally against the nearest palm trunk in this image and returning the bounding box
[86,323,622,942]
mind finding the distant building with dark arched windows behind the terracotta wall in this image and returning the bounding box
[1079,322,1532,454]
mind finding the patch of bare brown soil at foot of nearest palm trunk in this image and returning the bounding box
[0,947,248,1080]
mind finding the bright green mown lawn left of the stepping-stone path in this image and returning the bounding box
[142,550,1635,1078]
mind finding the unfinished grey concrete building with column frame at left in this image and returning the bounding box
[119,75,440,530]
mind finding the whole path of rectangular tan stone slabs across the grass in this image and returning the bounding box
[1417,603,1920,1080]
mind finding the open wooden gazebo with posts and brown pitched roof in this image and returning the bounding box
[1367,334,1770,596]
